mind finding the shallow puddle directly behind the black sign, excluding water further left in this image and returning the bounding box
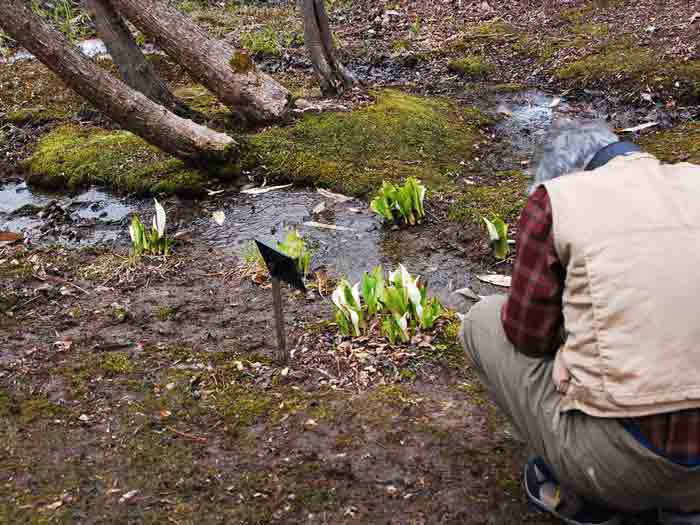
[193,191,469,290]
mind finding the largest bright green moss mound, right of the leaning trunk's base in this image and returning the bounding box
[244,91,480,196]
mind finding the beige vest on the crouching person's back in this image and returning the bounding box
[545,153,700,417]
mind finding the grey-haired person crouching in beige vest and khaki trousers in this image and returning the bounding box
[462,122,700,525]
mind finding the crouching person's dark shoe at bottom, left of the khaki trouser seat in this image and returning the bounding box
[523,458,620,525]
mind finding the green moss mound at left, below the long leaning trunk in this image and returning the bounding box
[27,125,207,195]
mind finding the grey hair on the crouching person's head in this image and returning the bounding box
[528,119,619,194]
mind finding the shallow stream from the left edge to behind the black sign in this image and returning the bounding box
[0,182,470,299]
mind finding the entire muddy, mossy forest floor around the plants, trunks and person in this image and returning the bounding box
[0,0,700,524]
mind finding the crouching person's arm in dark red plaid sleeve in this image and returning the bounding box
[501,186,565,357]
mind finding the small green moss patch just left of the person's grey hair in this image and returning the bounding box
[449,171,528,224]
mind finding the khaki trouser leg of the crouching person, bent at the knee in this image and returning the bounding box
[461,296,700,511]
